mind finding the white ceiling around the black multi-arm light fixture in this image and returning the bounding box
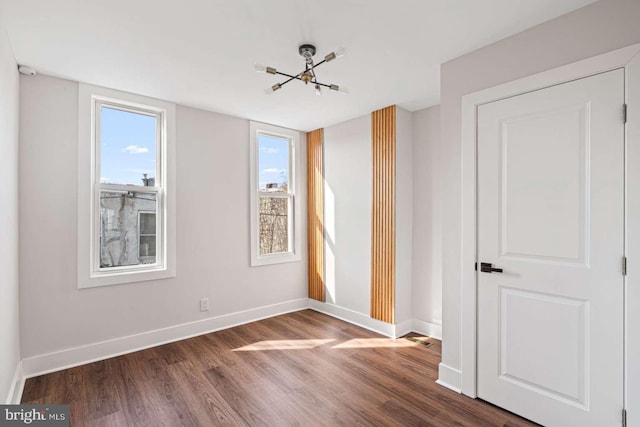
[0,0,594,131]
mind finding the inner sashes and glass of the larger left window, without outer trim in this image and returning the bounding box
[99,104,164,271]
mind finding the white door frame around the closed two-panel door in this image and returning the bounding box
[460,43,640,407]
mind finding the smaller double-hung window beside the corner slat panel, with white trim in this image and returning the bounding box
[250,122,300,266]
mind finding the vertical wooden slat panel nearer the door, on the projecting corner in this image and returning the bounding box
[371,105,396,323]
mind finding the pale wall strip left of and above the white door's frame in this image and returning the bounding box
[440,0,640,390]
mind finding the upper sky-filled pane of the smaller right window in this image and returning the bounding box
[258,134,289,192]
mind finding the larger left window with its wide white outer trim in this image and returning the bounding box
[78,85,175,288]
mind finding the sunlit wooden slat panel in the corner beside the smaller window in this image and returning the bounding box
[307,129,324,302]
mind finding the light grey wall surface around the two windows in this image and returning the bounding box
[19,76,307,359]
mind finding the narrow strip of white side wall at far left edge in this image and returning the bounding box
[0,22,20,403]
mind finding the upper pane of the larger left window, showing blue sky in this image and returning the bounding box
[100,105,157,186]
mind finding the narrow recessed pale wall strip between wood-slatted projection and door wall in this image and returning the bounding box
[412,106,442,336]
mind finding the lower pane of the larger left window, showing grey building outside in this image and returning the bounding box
[100,191,157,268]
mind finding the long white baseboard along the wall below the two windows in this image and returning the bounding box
[22,298,309,378]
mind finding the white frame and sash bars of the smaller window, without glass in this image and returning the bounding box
[249,121,302,267]
